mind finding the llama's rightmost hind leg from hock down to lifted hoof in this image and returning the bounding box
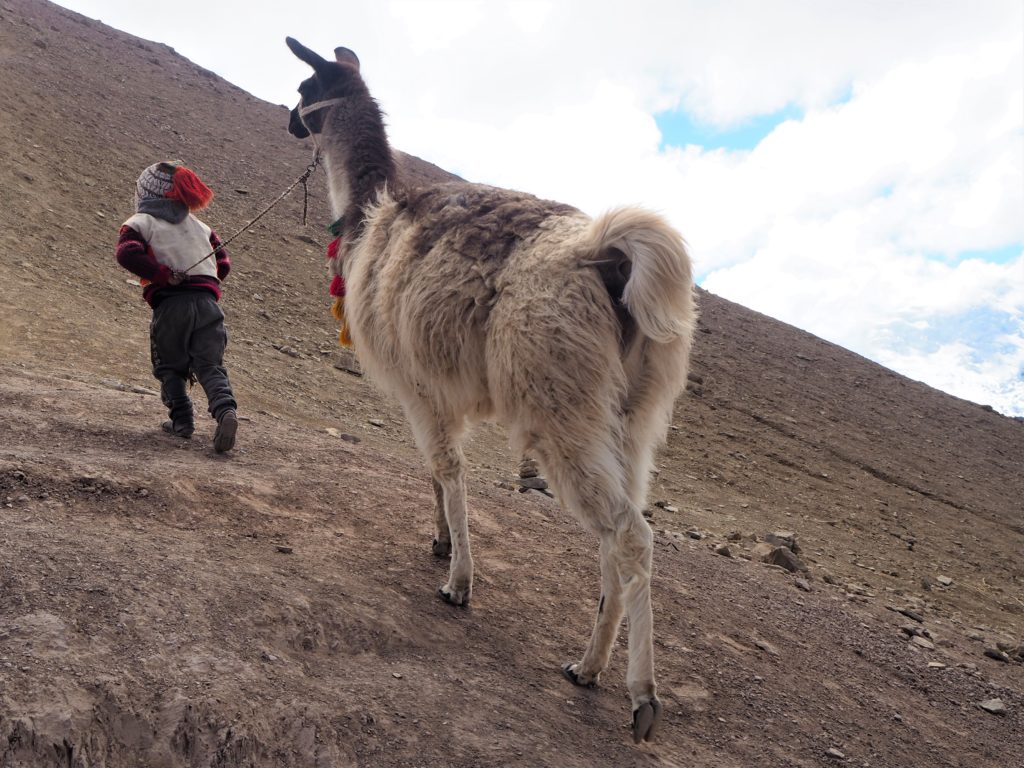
[612,508,662,741]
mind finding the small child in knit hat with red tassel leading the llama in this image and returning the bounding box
[117,162,239,454]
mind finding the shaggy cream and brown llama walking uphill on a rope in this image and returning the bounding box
[287,38,696,741]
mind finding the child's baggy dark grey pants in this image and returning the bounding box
[150,291,237,424]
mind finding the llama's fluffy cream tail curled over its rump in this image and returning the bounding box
[588,208,696,343]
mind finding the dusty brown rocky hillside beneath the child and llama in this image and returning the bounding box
[0,0,1024,768]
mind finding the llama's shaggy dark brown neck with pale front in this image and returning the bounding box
[322,96,395,237]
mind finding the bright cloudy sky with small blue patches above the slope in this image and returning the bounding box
[59,0,1024,416]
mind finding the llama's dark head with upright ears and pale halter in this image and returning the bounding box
[285,37,367,138]
